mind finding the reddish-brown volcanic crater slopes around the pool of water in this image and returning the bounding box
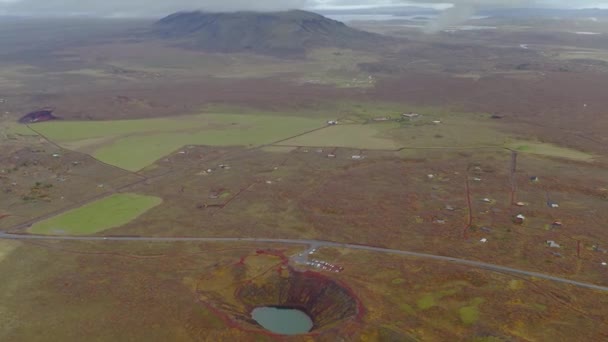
[198,252,363,334]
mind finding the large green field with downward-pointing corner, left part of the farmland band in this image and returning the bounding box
[36,113,325,171]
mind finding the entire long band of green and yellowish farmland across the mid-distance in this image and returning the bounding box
[27,102,592,171]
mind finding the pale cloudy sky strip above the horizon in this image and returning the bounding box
[0,0,608,16]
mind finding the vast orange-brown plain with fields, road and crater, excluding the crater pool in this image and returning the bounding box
[0,9,608,341]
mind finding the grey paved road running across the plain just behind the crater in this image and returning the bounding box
[0,232,608,292]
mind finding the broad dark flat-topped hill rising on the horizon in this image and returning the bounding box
[153,10,388,56]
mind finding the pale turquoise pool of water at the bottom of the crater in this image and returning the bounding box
[251,306,313,335]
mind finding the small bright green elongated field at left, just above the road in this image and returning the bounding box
[29,194,162,235]
